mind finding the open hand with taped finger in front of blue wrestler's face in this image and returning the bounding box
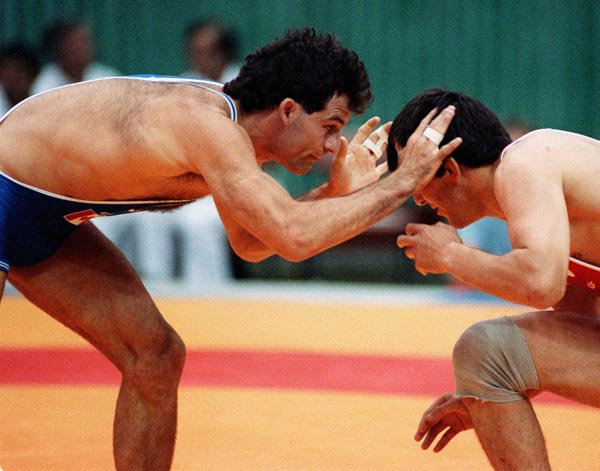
[329,117,392,196]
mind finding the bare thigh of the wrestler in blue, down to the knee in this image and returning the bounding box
[9,224,172,366]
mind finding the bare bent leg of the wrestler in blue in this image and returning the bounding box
[9,224,185,471]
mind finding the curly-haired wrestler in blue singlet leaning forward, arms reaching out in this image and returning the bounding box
[0,29,460,471]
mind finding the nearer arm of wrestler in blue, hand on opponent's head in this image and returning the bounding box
[202,107,460,261]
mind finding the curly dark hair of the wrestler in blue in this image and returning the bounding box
[223,28,373,114]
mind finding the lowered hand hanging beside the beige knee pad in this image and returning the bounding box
[415,393,473,453]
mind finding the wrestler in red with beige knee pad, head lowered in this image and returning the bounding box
[388,90,600,471]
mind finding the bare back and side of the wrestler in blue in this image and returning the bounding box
[0,77,238,200]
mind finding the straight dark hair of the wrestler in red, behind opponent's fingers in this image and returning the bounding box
[387,88,511,171]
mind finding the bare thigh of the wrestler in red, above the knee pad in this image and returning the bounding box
[513,311,600,407]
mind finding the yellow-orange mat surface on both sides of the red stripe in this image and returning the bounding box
[0,296,600,471]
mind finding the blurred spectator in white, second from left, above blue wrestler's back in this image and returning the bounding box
[32,19,119,93]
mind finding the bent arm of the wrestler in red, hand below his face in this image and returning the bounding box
[398,149,569,309]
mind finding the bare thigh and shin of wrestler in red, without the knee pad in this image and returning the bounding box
[464,311,600,470]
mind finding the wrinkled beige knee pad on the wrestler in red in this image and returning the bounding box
[452,317,539,402]
